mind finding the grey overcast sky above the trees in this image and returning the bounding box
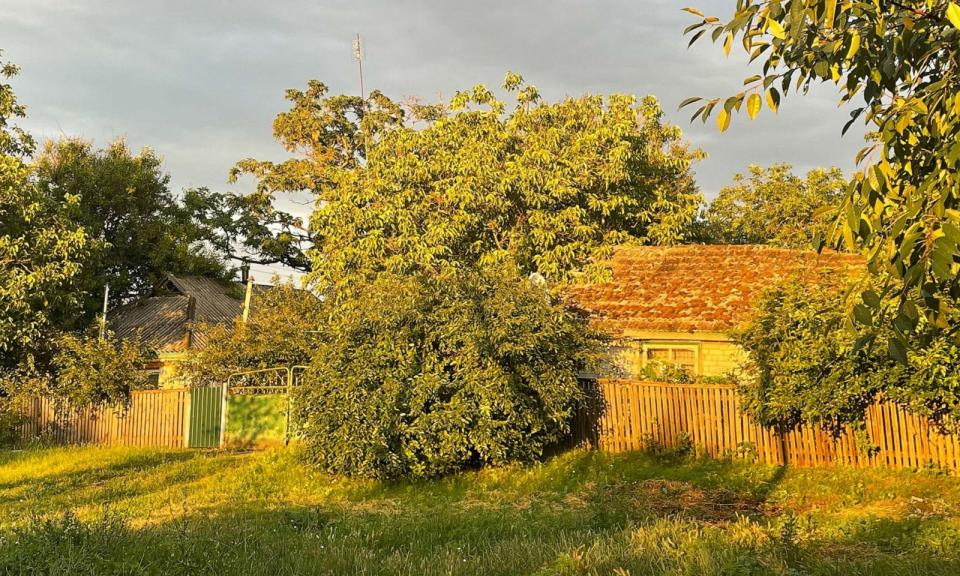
[0,0,863,280]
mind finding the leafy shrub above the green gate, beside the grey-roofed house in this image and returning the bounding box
[179,283,323,385]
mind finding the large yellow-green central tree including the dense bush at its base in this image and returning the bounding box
[231,74,700,477]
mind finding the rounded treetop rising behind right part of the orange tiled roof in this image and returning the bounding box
[704,164,847,249]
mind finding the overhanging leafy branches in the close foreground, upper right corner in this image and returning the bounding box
[684,0,960,356]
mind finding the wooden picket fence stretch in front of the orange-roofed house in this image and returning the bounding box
[579,381,960,472]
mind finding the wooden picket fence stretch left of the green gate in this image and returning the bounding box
[21,389,190,448]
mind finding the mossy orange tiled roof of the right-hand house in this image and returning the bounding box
[569,245,864,335]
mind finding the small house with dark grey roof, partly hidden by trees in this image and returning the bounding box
[108,273,269,387]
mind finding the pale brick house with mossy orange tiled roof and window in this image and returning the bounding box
[570,245,864,378]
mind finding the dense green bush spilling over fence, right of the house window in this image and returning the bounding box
[738,280,960,431]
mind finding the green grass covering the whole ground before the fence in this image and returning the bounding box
[0,448,960,576]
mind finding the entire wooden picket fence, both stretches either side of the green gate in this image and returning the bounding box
[13,381,960,473]
